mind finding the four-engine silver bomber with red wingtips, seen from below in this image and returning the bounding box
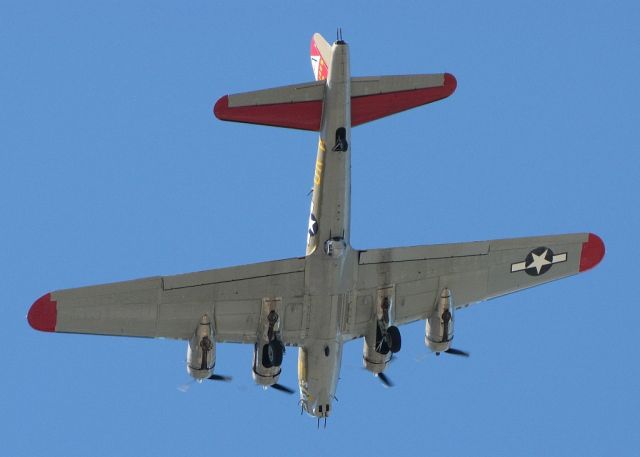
[27,33,605,425]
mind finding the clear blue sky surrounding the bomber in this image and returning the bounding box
[0,1,640,457]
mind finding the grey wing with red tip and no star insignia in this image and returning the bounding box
[28,258,304,345]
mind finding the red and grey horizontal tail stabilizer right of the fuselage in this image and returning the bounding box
[351,73,457,127]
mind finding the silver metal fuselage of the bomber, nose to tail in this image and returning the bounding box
[298,42,356,418]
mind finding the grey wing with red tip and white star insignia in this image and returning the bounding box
[353,233,604,335]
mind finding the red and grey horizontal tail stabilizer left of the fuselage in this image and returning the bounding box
[213,81,326,131]
